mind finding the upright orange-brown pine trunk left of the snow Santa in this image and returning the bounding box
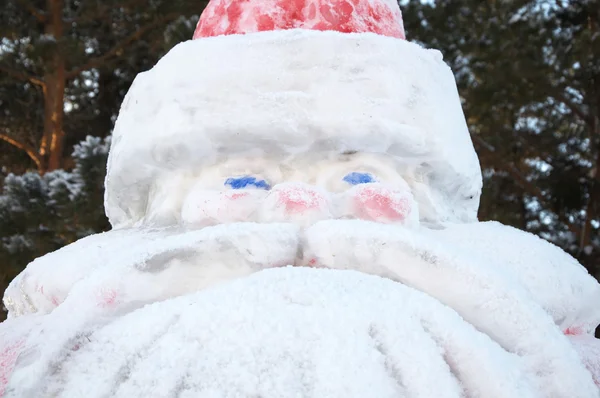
[40,0,66,171]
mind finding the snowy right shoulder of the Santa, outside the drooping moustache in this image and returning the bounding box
[430,222,600,332]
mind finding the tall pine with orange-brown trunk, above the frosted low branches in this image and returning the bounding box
[0,0,203,173]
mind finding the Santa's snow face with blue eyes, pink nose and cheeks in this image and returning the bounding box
[146,153,419,229]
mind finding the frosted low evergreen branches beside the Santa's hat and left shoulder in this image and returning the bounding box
[0,137,110,319]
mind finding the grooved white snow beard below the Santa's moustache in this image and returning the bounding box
[1,268,595,398]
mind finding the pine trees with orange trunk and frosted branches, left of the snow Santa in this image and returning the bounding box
[0,0,205,318]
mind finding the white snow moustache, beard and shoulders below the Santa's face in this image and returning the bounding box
[0,220,600,397]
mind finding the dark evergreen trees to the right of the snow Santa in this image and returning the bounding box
[403,0,600,277]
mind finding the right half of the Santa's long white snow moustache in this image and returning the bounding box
[298,220,597,397]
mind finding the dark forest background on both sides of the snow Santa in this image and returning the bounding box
[0,0,600,320]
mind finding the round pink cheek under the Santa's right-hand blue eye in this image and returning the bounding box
[354,188,411,222]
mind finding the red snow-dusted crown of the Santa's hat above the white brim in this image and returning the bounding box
[194,0,405,39]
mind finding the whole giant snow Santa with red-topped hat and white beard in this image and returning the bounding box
[0,0,600,398]
